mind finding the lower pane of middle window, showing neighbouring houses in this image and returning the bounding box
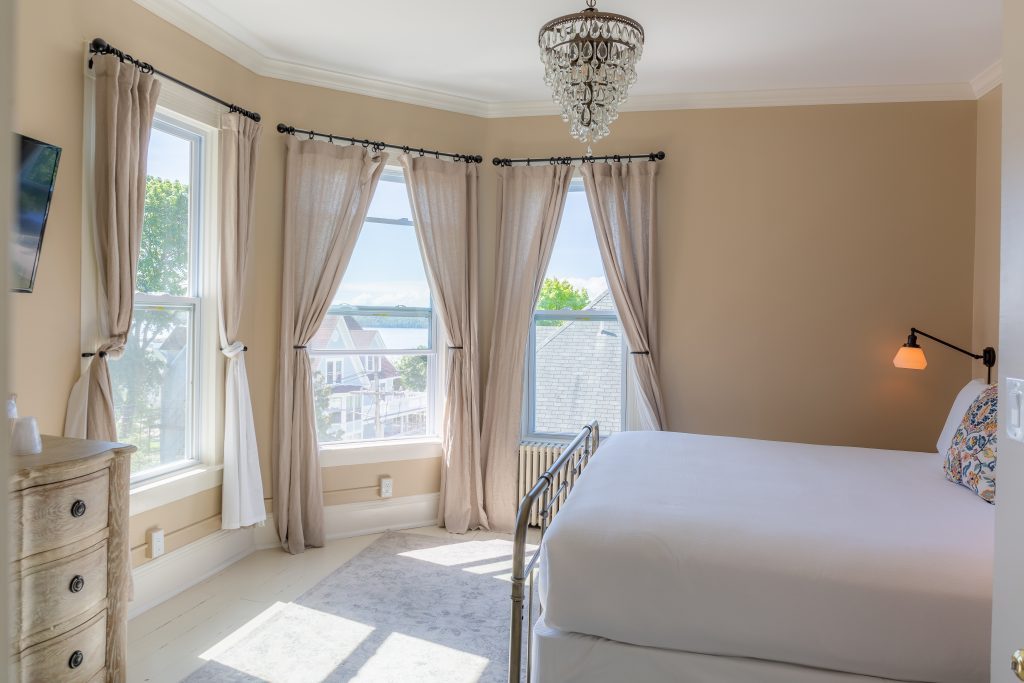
[310,354,432,442]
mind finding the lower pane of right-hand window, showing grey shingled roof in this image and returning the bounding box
[534,315,623,433]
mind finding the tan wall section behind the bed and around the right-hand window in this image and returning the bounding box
[482,102,976,451]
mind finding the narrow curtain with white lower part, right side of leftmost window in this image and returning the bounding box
[219,112,266,528]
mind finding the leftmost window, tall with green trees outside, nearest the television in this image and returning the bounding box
[110,109,216,481]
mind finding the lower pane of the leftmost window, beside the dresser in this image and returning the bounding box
[110,306,193,474]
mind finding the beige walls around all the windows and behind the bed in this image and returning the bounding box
[9,0,984,561]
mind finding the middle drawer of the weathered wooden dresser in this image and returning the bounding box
[13,541,106,644]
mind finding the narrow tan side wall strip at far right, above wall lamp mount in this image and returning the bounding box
[971,87,1002,381]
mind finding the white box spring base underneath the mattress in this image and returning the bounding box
[530,617,908,683]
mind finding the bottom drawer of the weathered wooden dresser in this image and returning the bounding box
[14,611,106,683]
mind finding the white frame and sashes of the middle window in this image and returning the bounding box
[307,165,445,456]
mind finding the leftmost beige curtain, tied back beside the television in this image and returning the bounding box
[65,54,160,441]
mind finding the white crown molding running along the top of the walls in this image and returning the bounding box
[135,0,1001,119]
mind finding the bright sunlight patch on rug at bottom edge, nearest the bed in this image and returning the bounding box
[352,633,488,683]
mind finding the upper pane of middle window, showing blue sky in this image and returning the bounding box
[334,171,430,307]
